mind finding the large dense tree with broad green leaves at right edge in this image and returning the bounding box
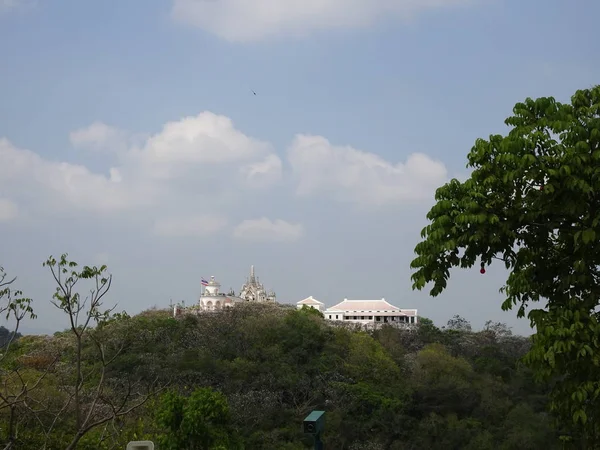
[411,86,600,448]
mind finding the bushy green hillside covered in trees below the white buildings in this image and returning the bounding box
[0,305,559,450]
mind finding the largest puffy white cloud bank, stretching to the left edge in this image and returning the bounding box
[0,112,281,219]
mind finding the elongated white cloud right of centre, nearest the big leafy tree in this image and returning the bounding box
[288,135,448,207]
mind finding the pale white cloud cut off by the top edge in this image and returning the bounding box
[171,0,476,41]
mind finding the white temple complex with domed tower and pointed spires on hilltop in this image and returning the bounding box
[173,266,276,317]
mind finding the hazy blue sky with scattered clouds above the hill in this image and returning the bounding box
[0,0,600,334]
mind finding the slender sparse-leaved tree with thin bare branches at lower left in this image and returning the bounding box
[30,254,155,450]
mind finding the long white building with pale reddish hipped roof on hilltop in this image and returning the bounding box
[323,298,418,325]
